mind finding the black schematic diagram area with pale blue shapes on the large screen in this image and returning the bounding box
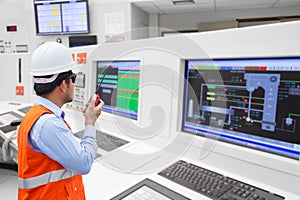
[186,67,300,141]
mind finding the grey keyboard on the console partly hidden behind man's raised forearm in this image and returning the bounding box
[74,130,128,151]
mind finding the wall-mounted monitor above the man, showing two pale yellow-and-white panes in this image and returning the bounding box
[34,0,89,35]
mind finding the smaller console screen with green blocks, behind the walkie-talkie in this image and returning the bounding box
[96,61,140,119]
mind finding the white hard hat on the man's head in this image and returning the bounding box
[30,42,78,76]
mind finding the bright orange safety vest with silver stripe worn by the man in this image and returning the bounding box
[18,105,85,200]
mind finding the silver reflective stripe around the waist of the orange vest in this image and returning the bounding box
[18,169,76,189]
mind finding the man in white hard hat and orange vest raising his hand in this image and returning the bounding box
[18,42,104,200]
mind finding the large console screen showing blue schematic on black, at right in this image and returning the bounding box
[182,58,300,159]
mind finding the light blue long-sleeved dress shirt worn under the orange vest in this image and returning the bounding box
[28,96,98,174]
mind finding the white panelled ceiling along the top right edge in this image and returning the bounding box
[131,0,300,14]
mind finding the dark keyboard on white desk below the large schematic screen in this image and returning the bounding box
[158,160,284,200]
